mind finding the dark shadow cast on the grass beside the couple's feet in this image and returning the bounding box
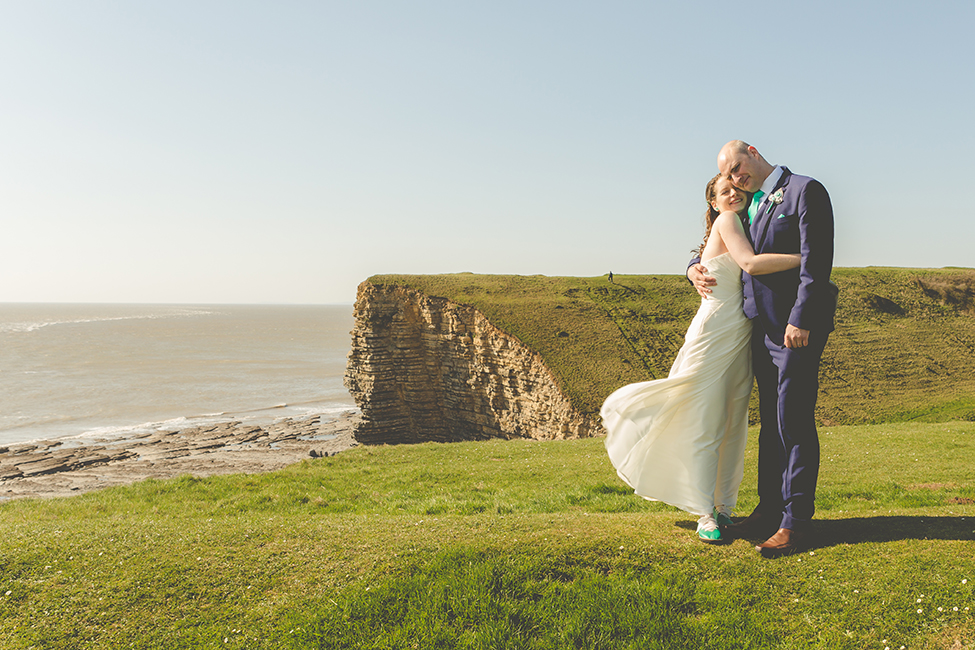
[675,516,975,550]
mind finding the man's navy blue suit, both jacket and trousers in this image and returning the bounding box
[691,168,836,530]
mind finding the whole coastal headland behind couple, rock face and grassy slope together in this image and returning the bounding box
[346,268,975,442]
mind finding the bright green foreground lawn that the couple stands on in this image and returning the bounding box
[0,422,975,649]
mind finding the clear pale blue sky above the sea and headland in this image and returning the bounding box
[0,0,975,303]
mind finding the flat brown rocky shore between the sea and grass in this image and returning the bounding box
[0,412,359,500]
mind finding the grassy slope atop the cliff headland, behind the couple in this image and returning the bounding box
[370,268,975,424]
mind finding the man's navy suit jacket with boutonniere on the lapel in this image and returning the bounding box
[742,167,836,345]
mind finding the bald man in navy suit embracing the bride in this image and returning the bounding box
[687,140,836,557]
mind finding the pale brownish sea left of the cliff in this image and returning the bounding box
[0,303,356,446]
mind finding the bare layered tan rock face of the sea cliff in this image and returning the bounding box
[345,282,603,444]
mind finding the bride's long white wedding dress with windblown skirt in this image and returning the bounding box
[600,253,752,515]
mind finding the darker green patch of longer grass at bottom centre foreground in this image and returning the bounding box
[284,549,774,650]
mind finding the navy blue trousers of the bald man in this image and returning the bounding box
[752,318,829,530]
